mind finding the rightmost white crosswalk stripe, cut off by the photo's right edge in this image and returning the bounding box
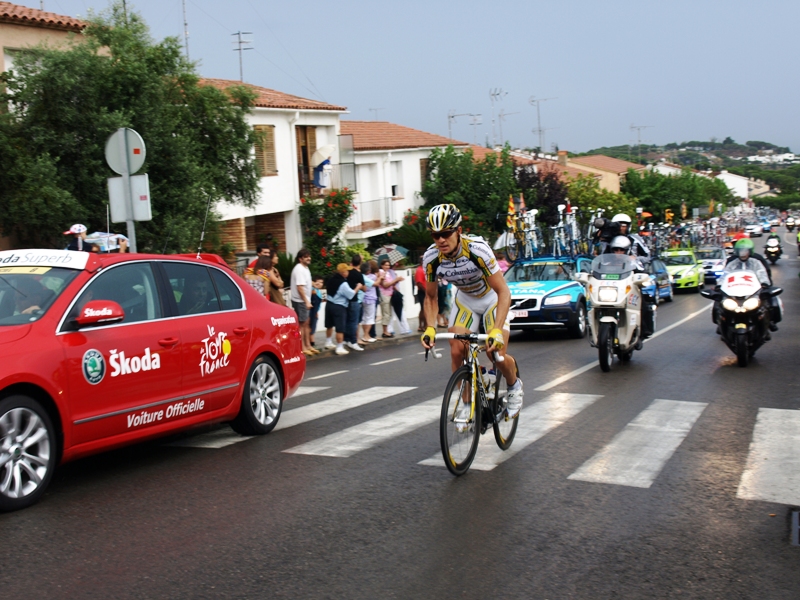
[736,408,800,506]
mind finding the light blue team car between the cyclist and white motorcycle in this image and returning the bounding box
[505,256,592,338]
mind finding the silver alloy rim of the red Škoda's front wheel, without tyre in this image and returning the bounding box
[0,407,50,499]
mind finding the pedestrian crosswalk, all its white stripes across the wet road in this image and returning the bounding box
[172,386,800,505]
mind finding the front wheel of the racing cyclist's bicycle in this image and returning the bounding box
[439,365,481,475]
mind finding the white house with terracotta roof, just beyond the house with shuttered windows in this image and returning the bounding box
[340,121,469,243]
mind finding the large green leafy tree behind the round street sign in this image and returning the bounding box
[0,4,258,252]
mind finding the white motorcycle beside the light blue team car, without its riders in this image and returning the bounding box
[575,254,656,371]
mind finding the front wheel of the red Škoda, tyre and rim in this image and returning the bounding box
[0,396,57,511]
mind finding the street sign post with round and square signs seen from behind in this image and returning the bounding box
[106,127,152,252]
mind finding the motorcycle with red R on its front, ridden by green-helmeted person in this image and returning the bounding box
[700,270,783,367]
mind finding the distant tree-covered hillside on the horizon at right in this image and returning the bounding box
[577,137,791,169]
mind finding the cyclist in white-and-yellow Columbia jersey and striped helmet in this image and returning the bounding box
[422,204,523,418]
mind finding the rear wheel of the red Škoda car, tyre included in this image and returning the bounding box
[231,356,284,435]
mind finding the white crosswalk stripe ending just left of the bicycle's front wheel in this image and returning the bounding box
[284,398,442,458]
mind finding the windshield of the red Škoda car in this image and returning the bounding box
[0,267,80,326]
